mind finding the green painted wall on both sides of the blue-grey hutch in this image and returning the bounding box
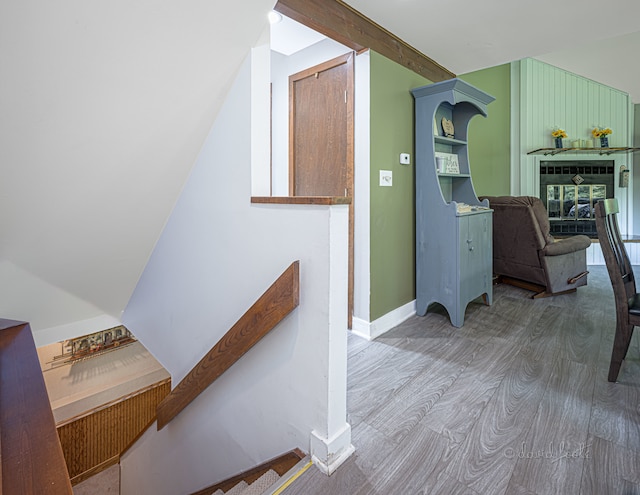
[369,57,511,321]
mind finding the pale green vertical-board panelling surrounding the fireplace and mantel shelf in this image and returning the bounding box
[512,59,633,234]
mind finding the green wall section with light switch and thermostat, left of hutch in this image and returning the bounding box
[370,51,431,321]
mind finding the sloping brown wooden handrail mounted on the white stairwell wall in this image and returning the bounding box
[157,261,300,430]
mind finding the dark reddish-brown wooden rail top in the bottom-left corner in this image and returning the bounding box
[0,319,73,495]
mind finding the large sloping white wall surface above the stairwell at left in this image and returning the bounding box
[0,0,275,345]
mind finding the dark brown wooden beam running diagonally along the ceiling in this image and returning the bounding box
[274,0,456,82]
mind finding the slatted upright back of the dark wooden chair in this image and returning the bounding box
[595,199,636,304]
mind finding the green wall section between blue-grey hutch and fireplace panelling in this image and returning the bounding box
[459,64,511,196]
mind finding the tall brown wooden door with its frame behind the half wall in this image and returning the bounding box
[289,53,354,328]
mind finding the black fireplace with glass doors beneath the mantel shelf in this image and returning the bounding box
[540,160,614,238]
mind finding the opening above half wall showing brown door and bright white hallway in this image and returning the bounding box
[271,16,355,328]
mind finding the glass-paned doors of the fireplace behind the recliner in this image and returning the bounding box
[547,184,607,222]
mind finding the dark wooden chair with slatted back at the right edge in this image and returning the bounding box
[595,199,640,382]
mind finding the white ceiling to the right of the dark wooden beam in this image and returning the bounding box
[346,0,640,103]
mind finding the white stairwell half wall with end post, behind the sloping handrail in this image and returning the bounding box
[121,54,352,495]
